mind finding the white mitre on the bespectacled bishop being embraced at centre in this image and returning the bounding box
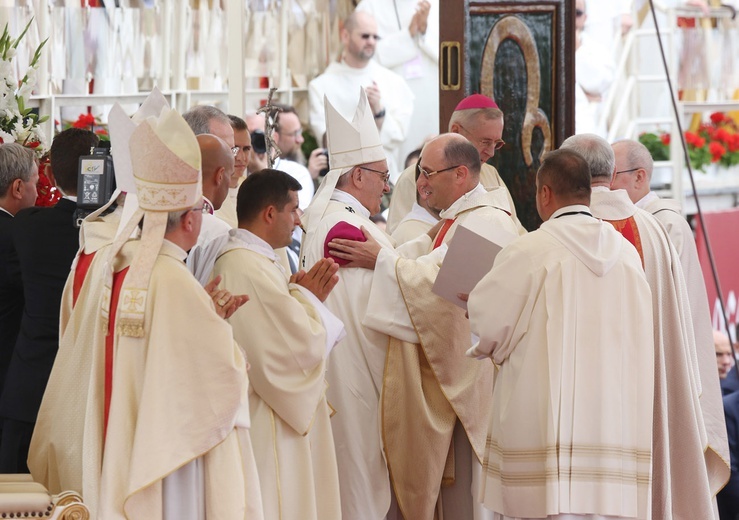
[300,88,386,230]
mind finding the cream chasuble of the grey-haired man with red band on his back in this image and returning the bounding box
[590,188,714,518]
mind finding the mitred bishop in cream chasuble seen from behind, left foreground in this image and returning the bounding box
[34,105,264,519]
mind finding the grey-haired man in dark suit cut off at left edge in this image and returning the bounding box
[0,143,38,426]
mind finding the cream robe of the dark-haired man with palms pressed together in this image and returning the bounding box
[213,229,341,520]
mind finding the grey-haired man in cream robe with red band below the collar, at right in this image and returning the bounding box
[562,134,729,518]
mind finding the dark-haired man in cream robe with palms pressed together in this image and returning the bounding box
[213,170,344,520]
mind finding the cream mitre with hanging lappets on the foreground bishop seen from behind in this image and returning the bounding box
[102,108,203,337]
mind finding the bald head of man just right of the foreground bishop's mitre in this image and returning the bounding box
[196,134,234,209]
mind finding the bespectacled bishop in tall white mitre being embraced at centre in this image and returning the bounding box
[301,91,395,520]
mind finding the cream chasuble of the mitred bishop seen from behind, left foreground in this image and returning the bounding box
[96,240,264,520]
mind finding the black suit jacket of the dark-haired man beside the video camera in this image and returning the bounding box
[0,199,79,422]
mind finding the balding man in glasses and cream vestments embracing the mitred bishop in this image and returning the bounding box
[329,134,518,520]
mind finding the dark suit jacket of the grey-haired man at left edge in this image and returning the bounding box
[0,211,23,396]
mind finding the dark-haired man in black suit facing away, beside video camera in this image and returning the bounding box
[0,128,98,473]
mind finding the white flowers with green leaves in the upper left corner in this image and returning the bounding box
[0,19,48,156]
